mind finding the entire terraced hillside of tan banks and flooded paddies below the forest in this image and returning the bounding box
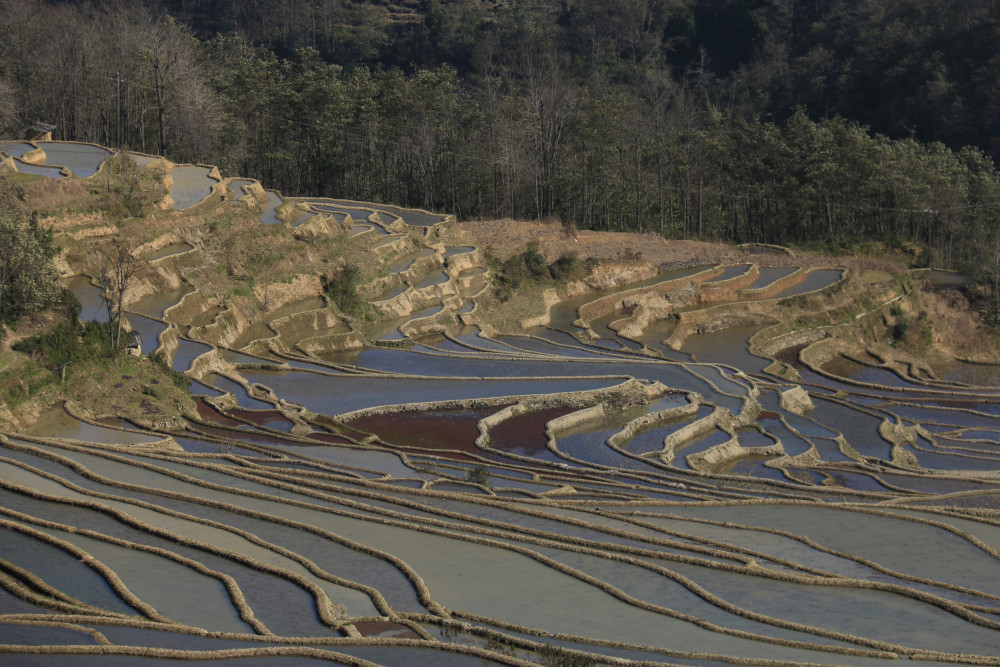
[0,138,1000,665]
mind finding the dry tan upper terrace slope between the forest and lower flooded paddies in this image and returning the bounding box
[3,139,995,440]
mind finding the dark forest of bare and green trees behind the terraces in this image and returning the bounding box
[0,0,1000,274]
